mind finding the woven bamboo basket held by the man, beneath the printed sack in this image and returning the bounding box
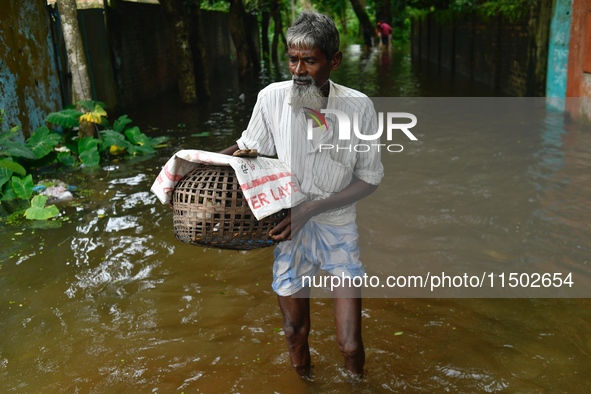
[172,165,286,250]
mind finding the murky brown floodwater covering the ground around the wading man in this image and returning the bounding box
[0,46,591,393]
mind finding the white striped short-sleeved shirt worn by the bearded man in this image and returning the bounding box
[237,80,384,225]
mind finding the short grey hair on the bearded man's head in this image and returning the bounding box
[285,11,340,60]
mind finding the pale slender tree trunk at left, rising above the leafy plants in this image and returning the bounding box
[57,0,92,103]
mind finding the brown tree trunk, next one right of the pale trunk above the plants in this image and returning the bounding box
[159,0,197,104]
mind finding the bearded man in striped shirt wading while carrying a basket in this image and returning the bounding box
[222,12,383,377]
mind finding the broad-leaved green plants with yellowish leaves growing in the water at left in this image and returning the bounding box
[0,100,168,220]
